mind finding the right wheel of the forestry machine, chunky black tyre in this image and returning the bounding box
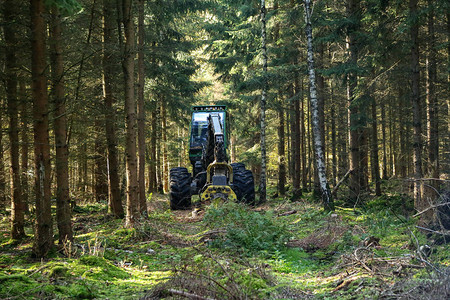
[233,164,255,205]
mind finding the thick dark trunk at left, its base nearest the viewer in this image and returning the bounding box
[30,0,53,258]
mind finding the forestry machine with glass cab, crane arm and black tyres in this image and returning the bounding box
[170,105,255,209]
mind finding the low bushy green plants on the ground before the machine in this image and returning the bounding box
[204,202,291,255]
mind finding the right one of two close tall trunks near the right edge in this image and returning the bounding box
[427,0,439,182]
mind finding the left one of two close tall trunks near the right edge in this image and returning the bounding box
[409,0,427,211]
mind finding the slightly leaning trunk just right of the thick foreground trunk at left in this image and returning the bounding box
[50,5,73,244]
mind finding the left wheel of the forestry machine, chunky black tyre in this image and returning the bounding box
[170,167,192,210]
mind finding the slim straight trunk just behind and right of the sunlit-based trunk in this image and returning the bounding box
[138,0,147,214]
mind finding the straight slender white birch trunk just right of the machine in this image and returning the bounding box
[259,0,267,202]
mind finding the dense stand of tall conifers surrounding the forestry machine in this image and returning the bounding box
[0,0,450,298]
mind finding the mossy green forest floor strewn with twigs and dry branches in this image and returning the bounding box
[0,179,450,299]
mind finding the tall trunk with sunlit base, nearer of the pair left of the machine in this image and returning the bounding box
[122,0,139,227]
